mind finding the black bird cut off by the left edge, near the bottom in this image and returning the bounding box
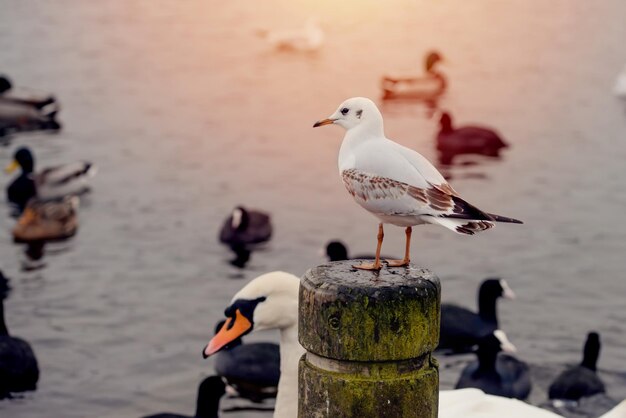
[0,297,39,399]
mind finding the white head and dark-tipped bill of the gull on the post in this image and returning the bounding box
[313,97,383,133]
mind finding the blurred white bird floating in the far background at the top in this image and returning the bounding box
[260,18,324,52]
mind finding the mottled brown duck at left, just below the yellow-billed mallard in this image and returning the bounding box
[13,196,78,243]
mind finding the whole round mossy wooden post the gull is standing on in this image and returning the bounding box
[298,260,441,418]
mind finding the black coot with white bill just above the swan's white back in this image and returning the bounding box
[456,330,531,400]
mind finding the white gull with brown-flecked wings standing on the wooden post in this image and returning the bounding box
[313,97,522,270]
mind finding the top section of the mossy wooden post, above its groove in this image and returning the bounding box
[299,261,441,361]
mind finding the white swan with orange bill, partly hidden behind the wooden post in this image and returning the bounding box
[203,271,626,418]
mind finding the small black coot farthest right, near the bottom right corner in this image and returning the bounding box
[548,332,604,401]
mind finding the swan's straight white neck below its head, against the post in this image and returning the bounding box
[274,323,304,418]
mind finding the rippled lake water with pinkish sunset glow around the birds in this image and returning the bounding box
[0,0,626,418]
